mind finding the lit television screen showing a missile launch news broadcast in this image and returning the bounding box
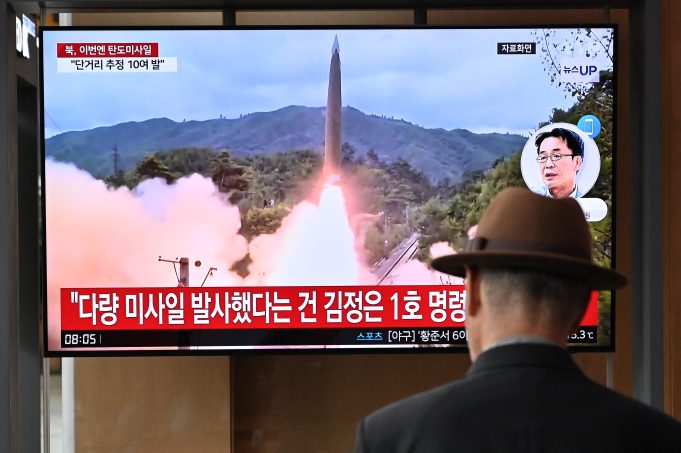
[40,27,615,356]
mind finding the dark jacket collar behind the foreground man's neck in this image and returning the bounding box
[466,343,582,377]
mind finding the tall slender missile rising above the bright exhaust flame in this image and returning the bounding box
[324,36,342,179]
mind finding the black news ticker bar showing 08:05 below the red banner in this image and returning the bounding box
[61,326,598,349]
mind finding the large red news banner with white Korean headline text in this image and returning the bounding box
[61,285,598,332]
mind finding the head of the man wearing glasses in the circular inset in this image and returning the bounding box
[534,127,584,198]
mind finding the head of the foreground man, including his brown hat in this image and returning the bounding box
[432,188,626,359]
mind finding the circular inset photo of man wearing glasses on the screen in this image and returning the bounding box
[520,123,601,198]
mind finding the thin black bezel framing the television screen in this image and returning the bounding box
[38,23,619,357]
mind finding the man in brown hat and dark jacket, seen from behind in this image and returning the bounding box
[356,189,681,453]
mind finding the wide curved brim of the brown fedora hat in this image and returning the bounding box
[430,251,627,289]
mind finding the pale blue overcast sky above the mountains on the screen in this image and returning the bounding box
[42,29,611,137]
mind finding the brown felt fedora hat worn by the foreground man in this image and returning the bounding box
[431,188,627,289]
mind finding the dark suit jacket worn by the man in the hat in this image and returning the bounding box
[356,344,681,453]
